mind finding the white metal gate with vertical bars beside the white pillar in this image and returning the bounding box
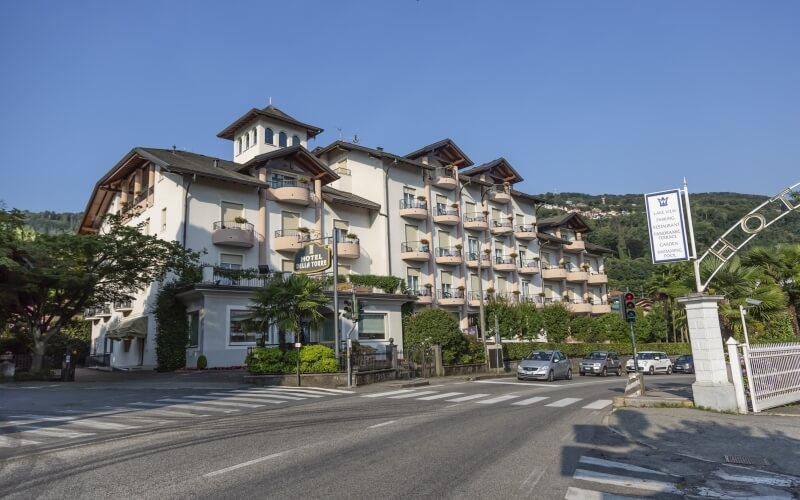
[742,342,800,412]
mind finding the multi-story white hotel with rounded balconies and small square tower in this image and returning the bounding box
[80,105,610,368]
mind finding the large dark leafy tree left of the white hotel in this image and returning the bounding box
[0,209,198,370]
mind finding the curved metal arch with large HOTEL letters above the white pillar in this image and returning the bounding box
[692,182,800,293]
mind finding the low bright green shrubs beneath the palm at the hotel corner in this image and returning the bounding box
[244,345,338,375]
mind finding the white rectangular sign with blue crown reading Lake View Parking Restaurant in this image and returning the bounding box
[644,189,689,264]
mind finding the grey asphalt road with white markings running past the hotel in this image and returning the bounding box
[0,375,720,499]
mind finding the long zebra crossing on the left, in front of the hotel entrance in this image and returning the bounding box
[0,387,353,450]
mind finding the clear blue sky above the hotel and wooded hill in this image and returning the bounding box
[0,0,800,211]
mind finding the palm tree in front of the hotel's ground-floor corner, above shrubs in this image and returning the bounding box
[250,273,329,349]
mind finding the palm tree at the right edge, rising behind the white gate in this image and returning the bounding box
[742,245,800,335]
